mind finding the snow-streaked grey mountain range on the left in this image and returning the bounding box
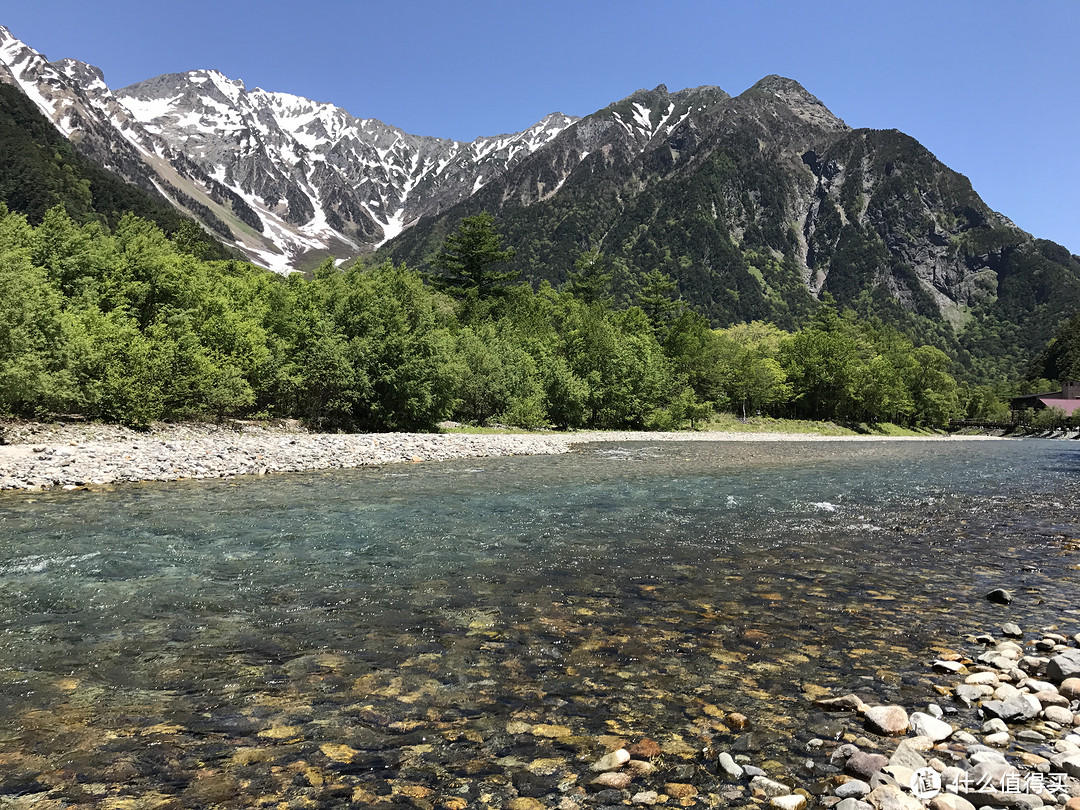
[0,27,577,271]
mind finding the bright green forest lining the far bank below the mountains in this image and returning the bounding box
[0,206,1019,431]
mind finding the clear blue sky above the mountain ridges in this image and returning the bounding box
[0,0,1080,254]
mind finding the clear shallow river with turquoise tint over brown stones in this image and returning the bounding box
[0,441,1080,807]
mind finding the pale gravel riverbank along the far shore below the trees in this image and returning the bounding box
[0,422,1002,489]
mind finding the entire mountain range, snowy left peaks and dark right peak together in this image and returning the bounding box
[0,28,1080,379]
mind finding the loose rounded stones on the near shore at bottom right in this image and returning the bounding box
[686,623,1080,810]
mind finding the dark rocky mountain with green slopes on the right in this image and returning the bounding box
[383,76,1080,379]
